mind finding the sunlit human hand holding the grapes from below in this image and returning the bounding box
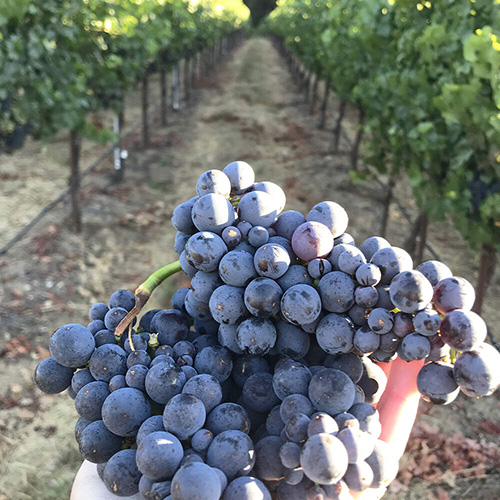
[70,358,423,500]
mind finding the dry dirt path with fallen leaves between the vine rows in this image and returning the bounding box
[0,39,500,500]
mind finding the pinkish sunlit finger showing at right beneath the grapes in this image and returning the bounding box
[377,358,424,456]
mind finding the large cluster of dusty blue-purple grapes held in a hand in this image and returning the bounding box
[34,161,500,500]
